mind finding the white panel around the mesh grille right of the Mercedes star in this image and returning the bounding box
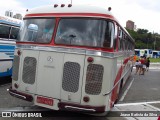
[61,53,85,103]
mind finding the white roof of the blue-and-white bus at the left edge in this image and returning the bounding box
[0,16,22,27]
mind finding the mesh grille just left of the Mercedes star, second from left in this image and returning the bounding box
[22,57,37,84]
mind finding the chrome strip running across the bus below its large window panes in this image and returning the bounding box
[16,45,133,58]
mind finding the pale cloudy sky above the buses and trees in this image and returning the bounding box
[0,0,160,34]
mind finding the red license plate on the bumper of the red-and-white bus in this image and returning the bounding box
[37,96,53,106]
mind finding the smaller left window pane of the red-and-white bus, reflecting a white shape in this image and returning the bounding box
[19,18,55,43]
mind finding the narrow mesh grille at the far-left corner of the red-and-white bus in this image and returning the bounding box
[12,55,20,80]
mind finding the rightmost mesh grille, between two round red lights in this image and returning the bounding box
[85,64,104,95]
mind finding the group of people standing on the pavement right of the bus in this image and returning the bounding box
[135,56,150,75]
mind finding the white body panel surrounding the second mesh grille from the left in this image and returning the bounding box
[18,50,39,93]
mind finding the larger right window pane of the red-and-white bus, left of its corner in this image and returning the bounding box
[55,18,114,47]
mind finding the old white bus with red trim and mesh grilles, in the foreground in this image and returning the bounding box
[8,4,134,113]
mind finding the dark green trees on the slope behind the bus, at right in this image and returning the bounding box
[127,29,160,50]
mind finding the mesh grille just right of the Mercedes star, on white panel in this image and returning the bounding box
[62,62,80,93]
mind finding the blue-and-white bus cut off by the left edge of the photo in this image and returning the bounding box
[0,16,21,79]
